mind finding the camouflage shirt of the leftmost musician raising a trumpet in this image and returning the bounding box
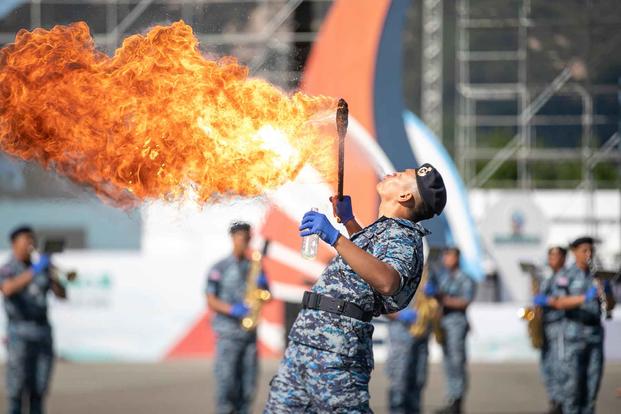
[0,257,51,339]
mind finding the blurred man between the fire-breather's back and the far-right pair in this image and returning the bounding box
[425,247,476,414]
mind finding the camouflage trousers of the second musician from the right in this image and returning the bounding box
[540,321,565,403]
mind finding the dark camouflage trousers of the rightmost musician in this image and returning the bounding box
[563,340,604,414]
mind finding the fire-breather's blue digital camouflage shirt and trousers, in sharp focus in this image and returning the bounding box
[265,217,426,414]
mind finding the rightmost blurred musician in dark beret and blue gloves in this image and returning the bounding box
[546,237,615,414]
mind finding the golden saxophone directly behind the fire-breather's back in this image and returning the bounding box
[410,252,444,344]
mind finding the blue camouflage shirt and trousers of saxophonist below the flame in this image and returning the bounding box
[207,255,258,414]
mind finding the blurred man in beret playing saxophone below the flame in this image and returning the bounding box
[207,222,269,414]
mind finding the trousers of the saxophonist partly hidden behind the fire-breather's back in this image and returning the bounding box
[386,306,431,414]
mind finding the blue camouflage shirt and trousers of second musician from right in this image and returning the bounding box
[539,268,569,403]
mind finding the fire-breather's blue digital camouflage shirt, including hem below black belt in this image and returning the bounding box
[289,217,428,366]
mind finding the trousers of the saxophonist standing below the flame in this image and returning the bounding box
[215,335,258,414]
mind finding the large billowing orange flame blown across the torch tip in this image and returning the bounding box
[0,22,336,207]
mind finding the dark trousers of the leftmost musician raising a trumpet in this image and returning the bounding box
[6,334,54,414]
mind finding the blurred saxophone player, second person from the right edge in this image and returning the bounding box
[534,246,569,414]
